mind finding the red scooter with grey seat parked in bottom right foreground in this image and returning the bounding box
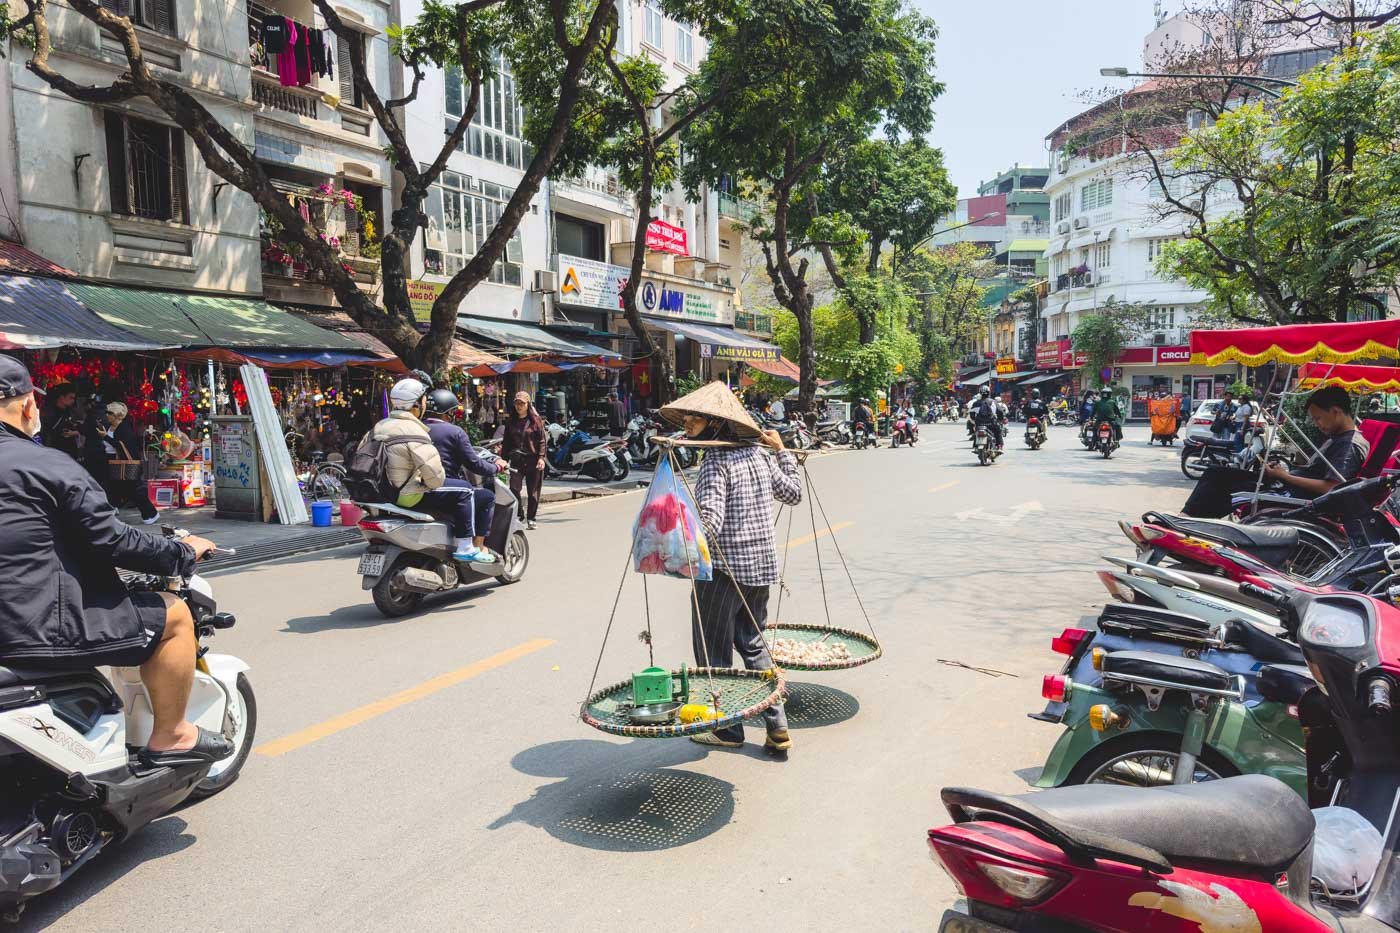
[928,584,1400,933]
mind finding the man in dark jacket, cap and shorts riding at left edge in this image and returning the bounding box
[0,356,234,768]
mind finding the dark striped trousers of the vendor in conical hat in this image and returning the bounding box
[690,570,787,740]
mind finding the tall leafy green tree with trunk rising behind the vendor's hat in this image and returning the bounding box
[682,0,942,408]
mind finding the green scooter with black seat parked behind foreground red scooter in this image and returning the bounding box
[1036,649,1313,797]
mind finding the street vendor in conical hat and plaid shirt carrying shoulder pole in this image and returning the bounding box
[661,382,802,752]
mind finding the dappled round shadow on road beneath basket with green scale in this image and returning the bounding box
[489,740,734,852]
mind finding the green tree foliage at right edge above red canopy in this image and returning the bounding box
[1152,28,1400,324]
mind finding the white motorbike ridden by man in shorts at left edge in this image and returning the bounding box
[0,530,258,922]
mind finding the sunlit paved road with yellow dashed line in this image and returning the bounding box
[22,426,1186,933]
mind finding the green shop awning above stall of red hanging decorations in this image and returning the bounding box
[69,284,363,352]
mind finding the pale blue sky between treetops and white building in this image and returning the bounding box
[910,0,1177,198]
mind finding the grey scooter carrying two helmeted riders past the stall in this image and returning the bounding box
[356,475,529,619]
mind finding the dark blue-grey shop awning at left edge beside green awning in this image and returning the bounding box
[0,276,172,352]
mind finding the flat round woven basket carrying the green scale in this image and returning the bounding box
[578,667,787,738]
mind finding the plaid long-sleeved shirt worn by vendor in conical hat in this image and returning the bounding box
[696,447,802,587]
